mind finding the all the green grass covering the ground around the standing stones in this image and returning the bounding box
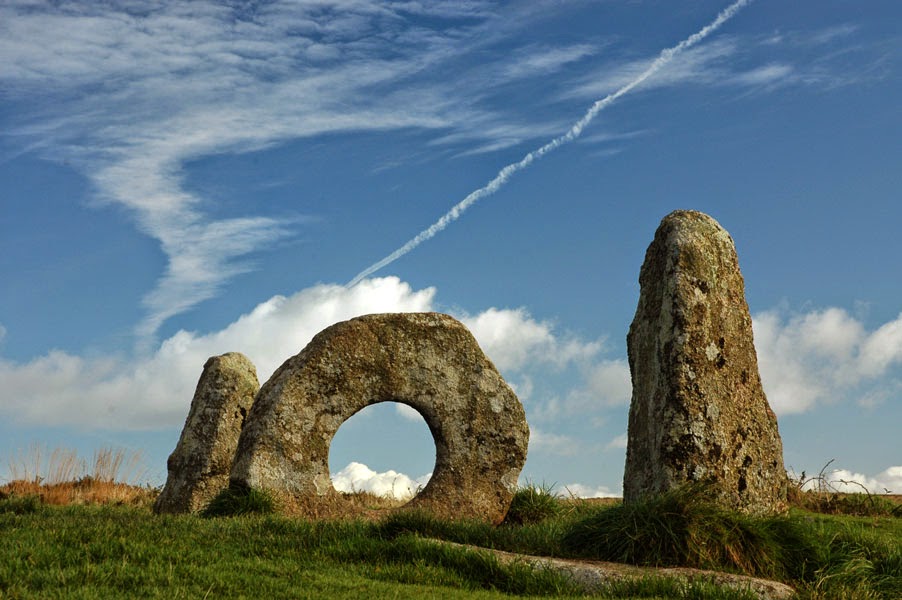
[0,490,902,600]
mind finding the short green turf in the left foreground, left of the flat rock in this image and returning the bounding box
[0,501,572,598]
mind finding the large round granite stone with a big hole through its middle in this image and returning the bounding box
[231,313,529,523]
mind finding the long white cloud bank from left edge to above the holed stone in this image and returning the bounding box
[0,277,435,430]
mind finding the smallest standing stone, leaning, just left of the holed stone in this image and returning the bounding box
[153,352,260,513]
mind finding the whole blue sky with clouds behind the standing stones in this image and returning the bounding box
[0,0,902,495]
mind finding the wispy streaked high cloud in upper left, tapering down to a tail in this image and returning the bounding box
[0,0,584,339]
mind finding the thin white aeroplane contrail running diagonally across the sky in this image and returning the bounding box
[346,0,752,287]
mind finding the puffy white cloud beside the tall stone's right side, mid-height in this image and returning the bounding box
[753,308,902,414]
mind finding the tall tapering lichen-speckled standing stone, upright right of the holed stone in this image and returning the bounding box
[623,211,787,513]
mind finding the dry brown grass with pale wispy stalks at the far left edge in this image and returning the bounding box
[0,444,158,506]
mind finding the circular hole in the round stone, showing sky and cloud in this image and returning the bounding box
[329,402,435,507]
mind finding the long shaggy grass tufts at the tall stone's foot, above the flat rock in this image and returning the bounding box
[561,487,902,598]
